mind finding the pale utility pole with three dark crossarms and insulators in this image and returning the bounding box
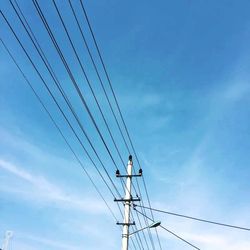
[114,155,142,250]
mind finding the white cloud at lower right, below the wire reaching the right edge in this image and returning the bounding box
[153,215,250,250]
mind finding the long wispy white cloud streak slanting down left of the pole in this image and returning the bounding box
[0,159,110,213]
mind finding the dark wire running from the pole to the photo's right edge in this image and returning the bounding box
[134,204,250,231]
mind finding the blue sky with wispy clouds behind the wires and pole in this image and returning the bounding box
[0,0,250,250]
